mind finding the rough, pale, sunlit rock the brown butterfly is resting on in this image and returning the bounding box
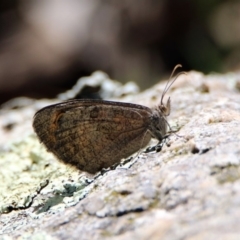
[0,72,240,240]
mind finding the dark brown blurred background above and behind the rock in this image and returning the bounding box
[0,0,240,103]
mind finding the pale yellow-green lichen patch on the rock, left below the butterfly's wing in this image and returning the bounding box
[0,135,93,214]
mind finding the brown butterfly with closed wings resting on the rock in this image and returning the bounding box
[33,65,182,173]
